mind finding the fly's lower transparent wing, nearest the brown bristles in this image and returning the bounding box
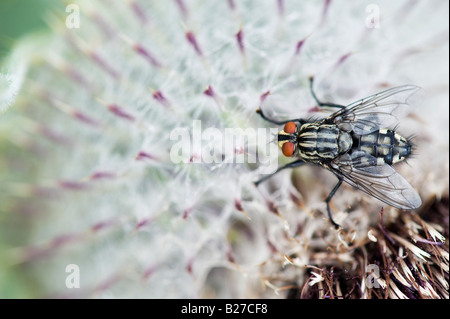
[329,151,422,209]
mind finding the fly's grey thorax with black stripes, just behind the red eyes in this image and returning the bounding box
[297,122,353,162]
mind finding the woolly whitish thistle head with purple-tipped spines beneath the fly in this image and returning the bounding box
[0,0,449,298]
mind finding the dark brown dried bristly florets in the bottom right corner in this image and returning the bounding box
[300,200,449,299]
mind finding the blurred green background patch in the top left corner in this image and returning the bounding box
[0,0,59,61]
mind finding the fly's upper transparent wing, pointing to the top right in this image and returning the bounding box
[327,85,420,135]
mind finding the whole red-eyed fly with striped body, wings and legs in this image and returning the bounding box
[255,77,422,228]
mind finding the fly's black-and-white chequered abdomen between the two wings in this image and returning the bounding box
[354,129,411,165]
